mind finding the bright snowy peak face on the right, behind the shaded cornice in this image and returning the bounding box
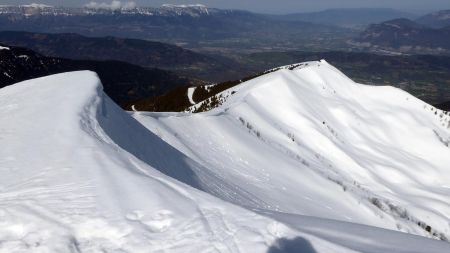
[134,61,450,240]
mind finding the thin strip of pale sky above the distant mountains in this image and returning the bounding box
[0,0,450,13]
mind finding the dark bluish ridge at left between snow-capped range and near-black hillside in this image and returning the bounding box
[0,31,242,81]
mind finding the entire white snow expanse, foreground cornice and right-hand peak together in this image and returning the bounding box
[0,62,450,253]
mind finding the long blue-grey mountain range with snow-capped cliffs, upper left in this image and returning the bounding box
[0,5,354,50]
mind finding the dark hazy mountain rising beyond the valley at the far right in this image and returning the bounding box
[353,19,450,54]
